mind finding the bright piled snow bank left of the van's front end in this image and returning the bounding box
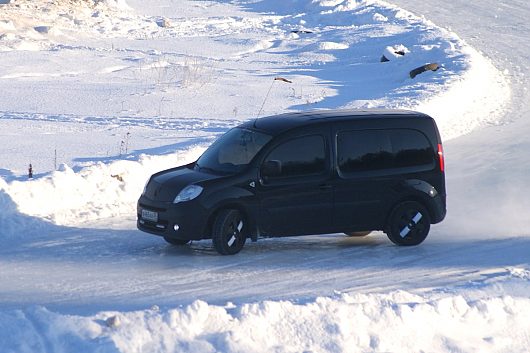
[0,146,204,230]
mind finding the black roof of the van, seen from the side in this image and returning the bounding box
[242,109,431,135]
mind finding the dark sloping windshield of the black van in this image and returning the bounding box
[195,128,272,174]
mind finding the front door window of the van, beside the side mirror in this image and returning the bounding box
[265,135,326,178]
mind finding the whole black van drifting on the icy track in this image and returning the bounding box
[137,110,446,254]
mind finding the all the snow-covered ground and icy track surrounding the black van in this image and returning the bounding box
[0,0,530,352]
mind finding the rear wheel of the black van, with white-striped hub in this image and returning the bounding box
[386,201,431,246]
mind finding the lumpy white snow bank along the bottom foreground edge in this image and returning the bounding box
[0,292,530,353]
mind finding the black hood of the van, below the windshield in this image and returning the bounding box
[144,165,222,202]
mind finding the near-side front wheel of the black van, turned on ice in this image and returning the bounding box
[212,210,247,255]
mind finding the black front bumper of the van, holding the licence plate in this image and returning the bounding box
[136,196,208,240]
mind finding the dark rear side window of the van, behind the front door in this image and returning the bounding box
[337,129,435,175]
